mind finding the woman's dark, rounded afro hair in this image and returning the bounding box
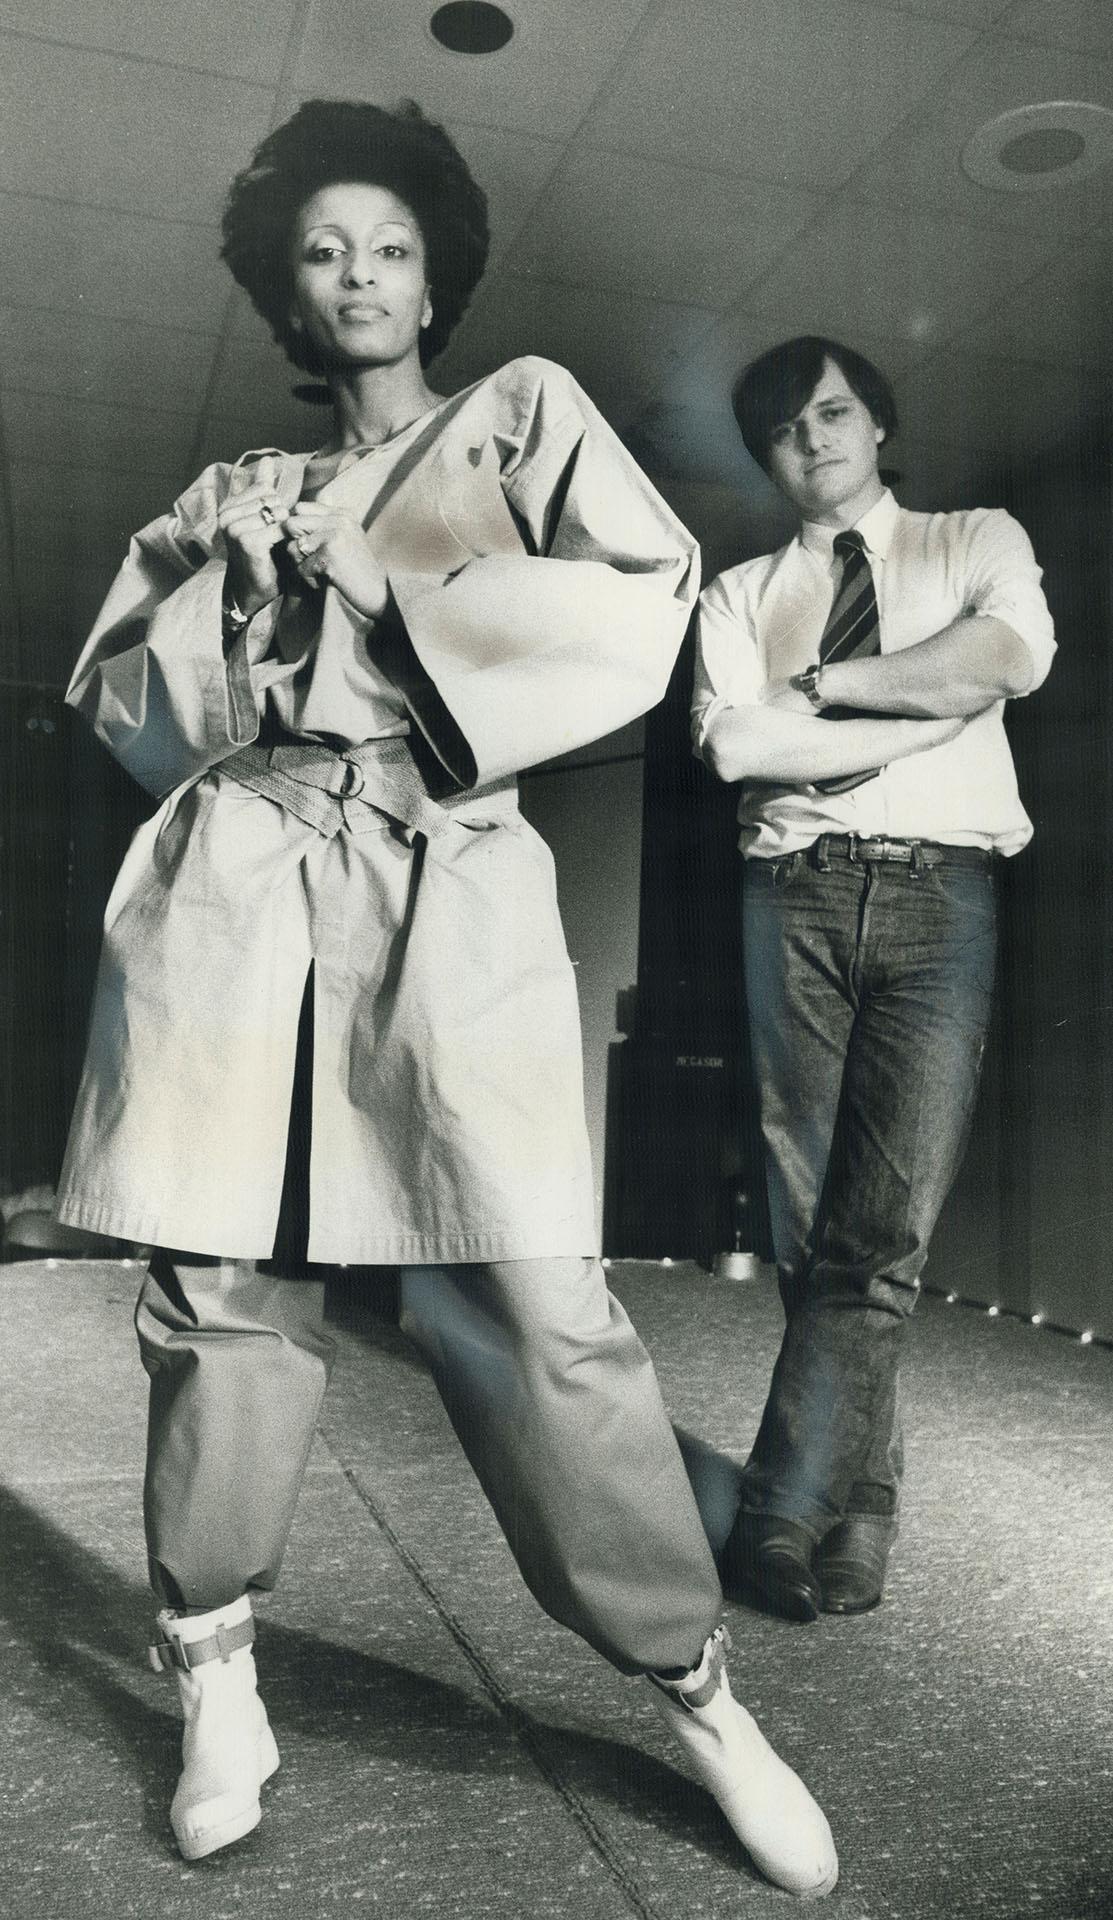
[221,100,489,372]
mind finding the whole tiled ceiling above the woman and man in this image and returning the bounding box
[0,0,1113,678]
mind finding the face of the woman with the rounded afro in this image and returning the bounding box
[292,180,432,367]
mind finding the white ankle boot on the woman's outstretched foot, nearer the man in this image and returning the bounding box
[647,1626,839,1899]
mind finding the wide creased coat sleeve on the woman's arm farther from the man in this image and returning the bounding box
[65,453,297,795]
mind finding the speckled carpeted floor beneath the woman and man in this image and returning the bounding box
[0,1263,1113,1920]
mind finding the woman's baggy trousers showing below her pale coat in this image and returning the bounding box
[136,1252,722,1672]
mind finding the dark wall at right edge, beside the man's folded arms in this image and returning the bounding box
[927,447,1113,1336]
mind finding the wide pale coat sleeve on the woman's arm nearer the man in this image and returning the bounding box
[388,359,699,785]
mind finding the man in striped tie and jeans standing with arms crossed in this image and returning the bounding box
[693,336,1054,1620]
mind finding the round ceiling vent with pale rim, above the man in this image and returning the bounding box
[961,100,1113,194]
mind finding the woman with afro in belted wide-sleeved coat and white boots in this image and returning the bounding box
[52,102,837,1891]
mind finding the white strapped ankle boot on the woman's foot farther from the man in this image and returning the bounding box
[152,1594,278,1860]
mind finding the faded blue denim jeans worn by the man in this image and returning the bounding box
[743,839,996,1540]
